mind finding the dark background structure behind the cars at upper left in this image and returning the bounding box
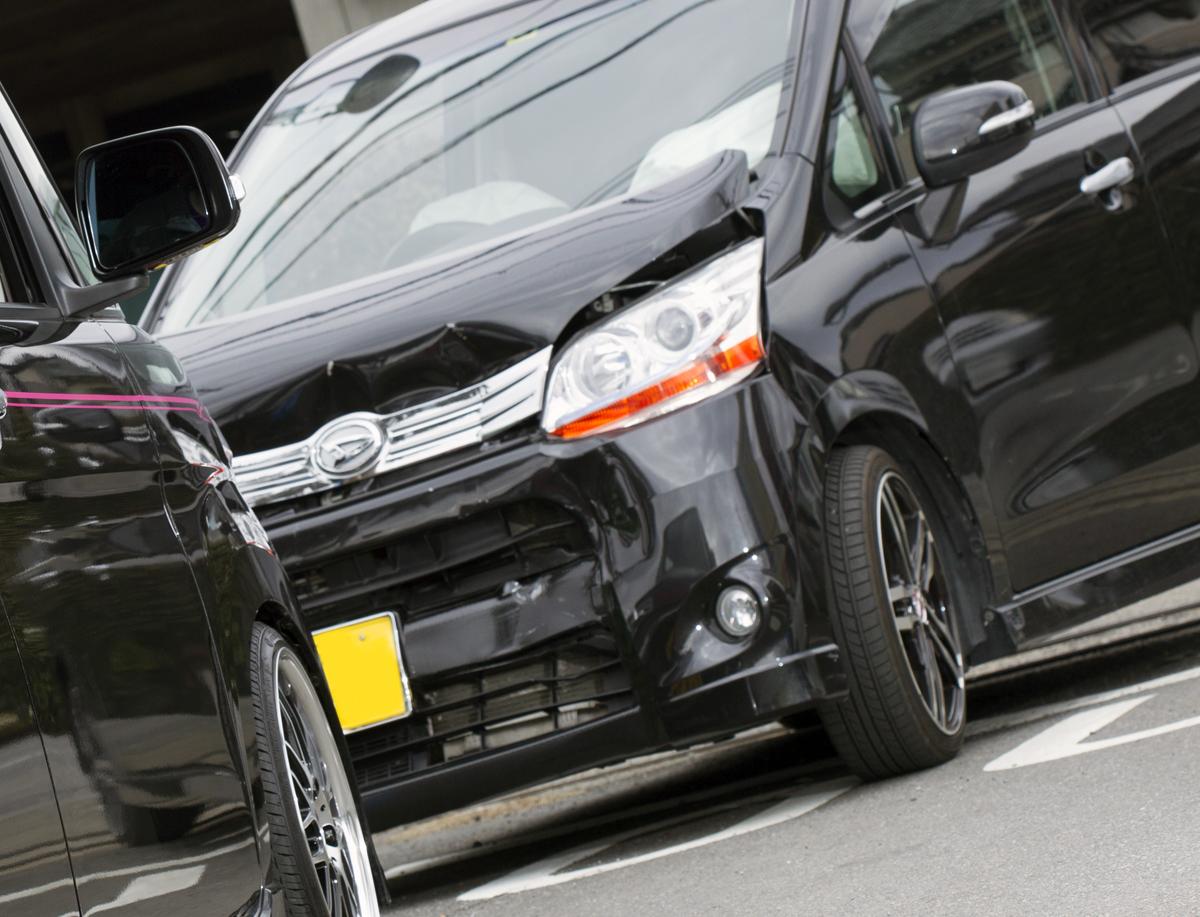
[0,0,420,192]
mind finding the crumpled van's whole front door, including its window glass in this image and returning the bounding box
[851,0,1200,590]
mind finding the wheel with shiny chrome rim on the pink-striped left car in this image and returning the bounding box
[251,624,379,917]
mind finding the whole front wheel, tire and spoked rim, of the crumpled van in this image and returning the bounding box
[818,446,966,780]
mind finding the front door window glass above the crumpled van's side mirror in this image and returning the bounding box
[850,0,1089,179]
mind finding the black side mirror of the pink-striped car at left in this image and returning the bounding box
[76,127,241,280]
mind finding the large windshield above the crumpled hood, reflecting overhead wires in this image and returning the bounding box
[160,0,796,331]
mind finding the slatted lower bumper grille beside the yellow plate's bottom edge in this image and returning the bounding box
[347,629,634,792]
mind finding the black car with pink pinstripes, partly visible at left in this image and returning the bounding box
[0,92,379,917]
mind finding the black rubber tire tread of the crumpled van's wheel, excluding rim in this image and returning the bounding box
[818,445,966,780]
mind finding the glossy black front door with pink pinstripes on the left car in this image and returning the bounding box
[0,306,262,917]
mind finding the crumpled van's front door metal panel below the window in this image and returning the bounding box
[912,106,1200,589]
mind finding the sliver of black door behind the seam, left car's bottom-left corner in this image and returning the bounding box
[0,607,79,917]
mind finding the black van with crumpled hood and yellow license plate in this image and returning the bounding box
[145,0,1200,828]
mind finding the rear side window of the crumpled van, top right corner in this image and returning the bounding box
[1081,0,1200,86]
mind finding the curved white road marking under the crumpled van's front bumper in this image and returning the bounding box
[458,779,858,901]
